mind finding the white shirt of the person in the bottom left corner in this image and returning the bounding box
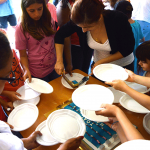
[0,121,24,150]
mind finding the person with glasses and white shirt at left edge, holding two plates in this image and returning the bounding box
[0,29,83,150]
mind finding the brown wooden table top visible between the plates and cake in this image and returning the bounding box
[21,69,150,150]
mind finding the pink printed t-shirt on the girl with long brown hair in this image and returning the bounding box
[15,21,56,78]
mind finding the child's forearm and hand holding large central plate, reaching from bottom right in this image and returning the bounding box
[96,104,144,141]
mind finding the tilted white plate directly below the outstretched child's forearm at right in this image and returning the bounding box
[120,94,150,114]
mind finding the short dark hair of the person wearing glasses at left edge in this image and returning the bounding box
[0,31,12,70]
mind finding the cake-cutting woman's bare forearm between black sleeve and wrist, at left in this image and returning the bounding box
[55,44,64,63]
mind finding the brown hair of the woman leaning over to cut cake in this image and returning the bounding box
[71,0,105,24]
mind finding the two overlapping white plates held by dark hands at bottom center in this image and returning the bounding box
[36,109,86,146]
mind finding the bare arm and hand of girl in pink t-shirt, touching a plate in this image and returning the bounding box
[19,50,31,82]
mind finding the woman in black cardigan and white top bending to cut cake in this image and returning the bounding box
[55,0,135,74]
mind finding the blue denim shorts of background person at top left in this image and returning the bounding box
[0,14,17,29]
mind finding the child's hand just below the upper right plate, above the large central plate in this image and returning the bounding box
[105,80,127,92]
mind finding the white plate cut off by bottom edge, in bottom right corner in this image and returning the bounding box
[115,140,150,150]
